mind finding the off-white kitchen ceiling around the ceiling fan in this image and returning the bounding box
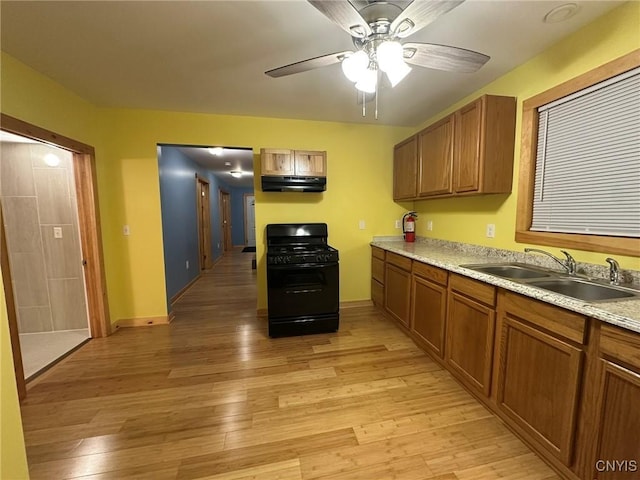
[0,0,622,126]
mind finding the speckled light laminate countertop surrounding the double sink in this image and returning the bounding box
[371,237,640,333]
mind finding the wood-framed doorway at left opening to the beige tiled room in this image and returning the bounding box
[0,114,110,399]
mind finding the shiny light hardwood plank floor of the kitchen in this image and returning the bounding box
[22,249,558,480]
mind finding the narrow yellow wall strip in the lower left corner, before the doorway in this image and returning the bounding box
[0,266,29,480]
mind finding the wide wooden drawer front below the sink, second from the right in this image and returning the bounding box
[499,291,587,345]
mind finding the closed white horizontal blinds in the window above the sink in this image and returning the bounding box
[531,68,640,237]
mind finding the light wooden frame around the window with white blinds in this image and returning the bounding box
[515,49,640,257]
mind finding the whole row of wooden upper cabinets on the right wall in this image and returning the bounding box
[393,95,516,200]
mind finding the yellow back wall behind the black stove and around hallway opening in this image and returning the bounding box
[103,110,410,312]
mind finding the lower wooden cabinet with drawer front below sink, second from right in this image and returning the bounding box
[496,292,587,474]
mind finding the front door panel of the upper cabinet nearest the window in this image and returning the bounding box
[454,99,482,192]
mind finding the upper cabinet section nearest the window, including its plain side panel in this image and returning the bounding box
[453,95,516,194]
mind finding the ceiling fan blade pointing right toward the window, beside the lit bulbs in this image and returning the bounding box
[402,43,491,73]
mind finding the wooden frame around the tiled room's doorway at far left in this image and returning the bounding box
[0,113,111,344]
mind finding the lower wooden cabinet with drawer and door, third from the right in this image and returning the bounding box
[445,274,496,397]
